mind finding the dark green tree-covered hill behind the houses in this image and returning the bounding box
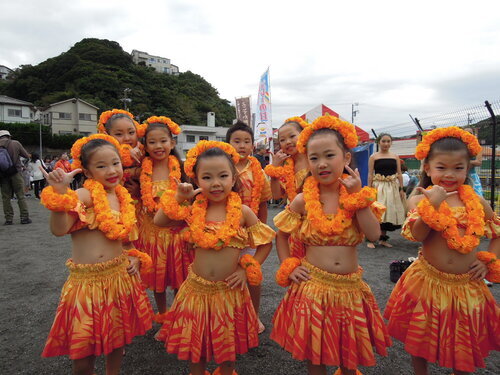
[0,39,235,126]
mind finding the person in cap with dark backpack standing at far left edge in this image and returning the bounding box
[0,130,31,225]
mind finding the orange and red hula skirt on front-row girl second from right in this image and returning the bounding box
[271,259,391,369]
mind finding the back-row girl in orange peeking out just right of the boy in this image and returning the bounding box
[264,117,308,258]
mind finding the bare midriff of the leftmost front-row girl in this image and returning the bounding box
[71,229,123,264]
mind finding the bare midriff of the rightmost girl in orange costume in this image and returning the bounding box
[422,229,476,274]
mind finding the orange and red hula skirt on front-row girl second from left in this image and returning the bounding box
[158,269,259,363]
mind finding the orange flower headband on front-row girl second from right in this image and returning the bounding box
[297,115,358,154]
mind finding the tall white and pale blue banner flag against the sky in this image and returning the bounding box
[254,68,273,143]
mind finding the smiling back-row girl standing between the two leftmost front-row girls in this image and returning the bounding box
[135,116,193,323]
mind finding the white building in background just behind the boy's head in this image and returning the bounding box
[177,112,228,158]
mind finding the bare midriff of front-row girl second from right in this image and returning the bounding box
[306,246,358,275]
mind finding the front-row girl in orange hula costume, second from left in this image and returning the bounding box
[155,141,275,375]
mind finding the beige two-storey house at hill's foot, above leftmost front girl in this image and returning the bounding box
[40,98,99,135]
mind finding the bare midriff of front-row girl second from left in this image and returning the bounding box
[193,247,241,281]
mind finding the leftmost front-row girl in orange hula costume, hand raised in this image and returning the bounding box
[41,134,152,375]
